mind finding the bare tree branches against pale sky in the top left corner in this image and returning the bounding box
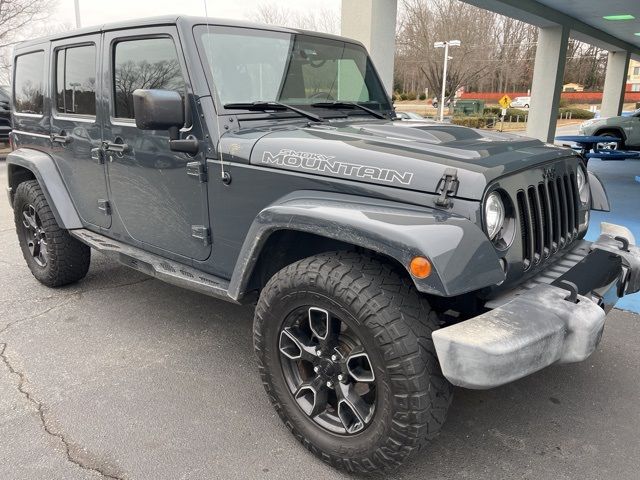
[0,0,68,85]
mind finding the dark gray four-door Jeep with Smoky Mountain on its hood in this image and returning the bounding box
[7,17,640,472]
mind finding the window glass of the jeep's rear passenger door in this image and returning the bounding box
[56,45,96,115]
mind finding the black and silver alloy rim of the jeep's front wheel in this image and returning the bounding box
[279,306,376,435]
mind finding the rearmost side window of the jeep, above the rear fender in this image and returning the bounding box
[13,51,44,115]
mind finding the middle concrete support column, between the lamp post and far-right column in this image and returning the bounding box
[527,26,569,142]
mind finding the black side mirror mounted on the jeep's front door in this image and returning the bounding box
[133,88,200,155]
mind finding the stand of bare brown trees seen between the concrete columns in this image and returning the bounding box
[395,0,606,96]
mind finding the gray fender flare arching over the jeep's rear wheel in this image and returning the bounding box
[7,148,83,230]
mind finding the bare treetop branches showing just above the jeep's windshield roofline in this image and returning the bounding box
[250,3,340,34]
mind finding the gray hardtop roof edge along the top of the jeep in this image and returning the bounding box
[16,15,362,50]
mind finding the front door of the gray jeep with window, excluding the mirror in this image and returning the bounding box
[103,27,211,260]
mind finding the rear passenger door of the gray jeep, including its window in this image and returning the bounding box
[51,34,111,228]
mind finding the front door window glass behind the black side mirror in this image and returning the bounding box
[112,38,185,118]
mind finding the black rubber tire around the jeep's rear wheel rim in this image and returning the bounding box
[13,180,91,287]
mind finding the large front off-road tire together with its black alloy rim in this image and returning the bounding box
[254,252,452,472]
